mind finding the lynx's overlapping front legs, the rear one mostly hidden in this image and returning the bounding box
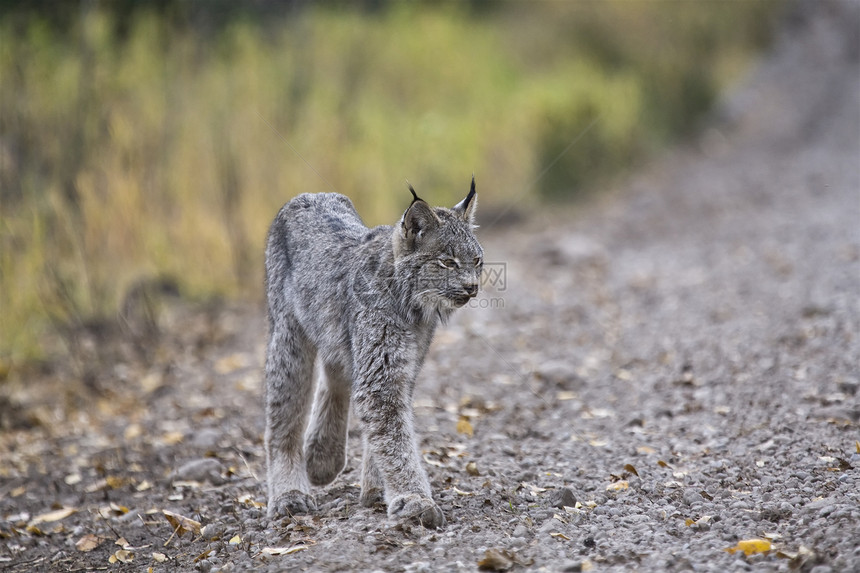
[353,322,445,527]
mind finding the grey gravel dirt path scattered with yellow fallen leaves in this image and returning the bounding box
[0,4,860,573]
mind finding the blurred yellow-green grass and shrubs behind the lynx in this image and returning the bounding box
[0,0,779,362]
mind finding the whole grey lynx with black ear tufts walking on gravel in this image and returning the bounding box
[265,176,483,527]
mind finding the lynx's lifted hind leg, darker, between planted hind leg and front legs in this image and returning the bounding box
[305,364,352,485]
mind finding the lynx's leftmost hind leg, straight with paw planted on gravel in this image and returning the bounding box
[266,315,316,517]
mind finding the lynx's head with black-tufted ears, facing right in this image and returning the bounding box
[394,176,484,321]
